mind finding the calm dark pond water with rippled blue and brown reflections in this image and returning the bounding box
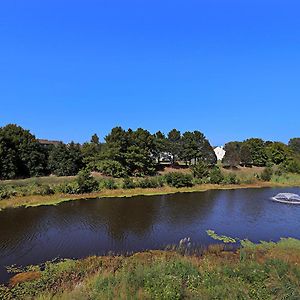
[0,188,300,282]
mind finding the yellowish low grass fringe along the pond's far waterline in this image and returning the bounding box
[0,174,300,210]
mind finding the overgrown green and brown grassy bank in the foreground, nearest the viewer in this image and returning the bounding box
[0,239,300,300]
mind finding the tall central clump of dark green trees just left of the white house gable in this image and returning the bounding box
[88,127,217,177]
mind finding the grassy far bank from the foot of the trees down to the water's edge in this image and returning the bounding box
[0,168,300,210]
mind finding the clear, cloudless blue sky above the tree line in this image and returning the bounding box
[0,0,300,145]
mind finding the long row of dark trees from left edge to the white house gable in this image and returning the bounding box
[0,124,216,179]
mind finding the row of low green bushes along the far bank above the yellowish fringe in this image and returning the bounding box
[0,160,300,200]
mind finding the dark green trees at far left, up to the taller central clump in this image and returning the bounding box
[0,124,83,179]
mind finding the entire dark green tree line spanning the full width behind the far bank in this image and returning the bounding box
[0,124,300,179]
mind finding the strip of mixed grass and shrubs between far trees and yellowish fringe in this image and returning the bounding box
[0,166,300,201]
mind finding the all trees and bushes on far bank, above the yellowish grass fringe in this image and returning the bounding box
[0,125,300,206]
